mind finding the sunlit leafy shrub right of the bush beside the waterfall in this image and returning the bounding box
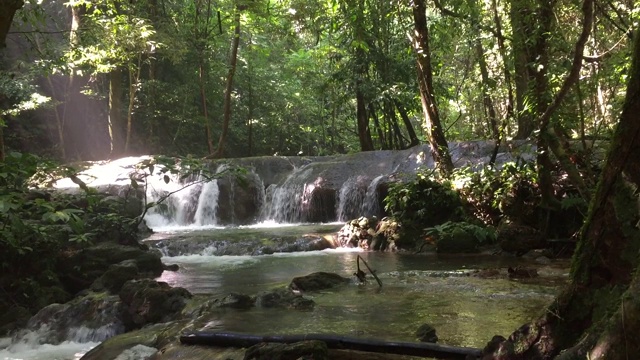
[452,162,538,225]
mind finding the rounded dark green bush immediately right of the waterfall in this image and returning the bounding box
[384,171,463,245]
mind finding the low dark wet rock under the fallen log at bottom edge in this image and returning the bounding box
[244,340,329,360]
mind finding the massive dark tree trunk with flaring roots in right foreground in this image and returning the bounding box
[483,22,640,360]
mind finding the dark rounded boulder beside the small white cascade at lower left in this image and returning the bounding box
[119,279,191,330]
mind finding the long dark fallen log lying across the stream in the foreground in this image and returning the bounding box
[180,331,482,359]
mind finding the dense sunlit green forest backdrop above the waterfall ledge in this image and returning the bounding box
[0,0,638,162]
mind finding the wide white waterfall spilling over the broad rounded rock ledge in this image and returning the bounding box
[50,142,524,229]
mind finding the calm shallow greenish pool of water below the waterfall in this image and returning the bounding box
[151,228,568,347]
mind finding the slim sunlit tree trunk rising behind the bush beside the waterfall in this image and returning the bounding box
[412,0,453,176]
